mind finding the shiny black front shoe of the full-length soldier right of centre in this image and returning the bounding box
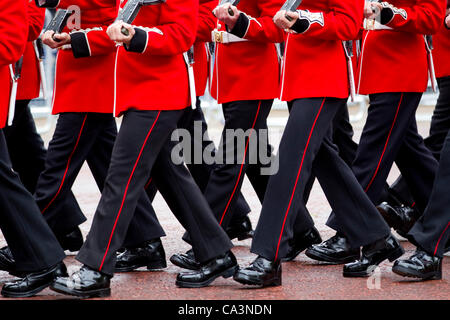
[233,256,281,287]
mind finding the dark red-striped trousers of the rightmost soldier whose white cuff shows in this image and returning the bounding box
[327,93,438,234]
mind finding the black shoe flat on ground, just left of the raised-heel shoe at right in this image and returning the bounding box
[305,233,359,264]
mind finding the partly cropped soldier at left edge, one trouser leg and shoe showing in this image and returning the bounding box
[0,0,67,297]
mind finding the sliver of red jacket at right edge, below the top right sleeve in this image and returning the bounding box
[433,25,450,78]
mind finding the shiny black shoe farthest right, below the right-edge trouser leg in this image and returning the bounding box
[392,249,442,280]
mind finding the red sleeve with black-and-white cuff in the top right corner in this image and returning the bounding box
[380,0,446,34]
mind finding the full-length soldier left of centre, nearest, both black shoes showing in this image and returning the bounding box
[51,0,238,297]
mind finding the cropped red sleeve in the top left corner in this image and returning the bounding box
[0,0,28,65]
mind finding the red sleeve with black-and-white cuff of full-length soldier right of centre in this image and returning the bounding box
[292,0,364,40]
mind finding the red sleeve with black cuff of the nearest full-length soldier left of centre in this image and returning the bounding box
[125,0,198,55]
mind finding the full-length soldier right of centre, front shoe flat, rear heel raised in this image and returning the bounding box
[234,0,404,286]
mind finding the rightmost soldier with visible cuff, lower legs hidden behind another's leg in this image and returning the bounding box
[313,0,445,264]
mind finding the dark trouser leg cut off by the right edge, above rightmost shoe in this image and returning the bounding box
[408,132,450,257]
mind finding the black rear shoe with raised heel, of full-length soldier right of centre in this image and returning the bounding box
[344,235,405,277]
